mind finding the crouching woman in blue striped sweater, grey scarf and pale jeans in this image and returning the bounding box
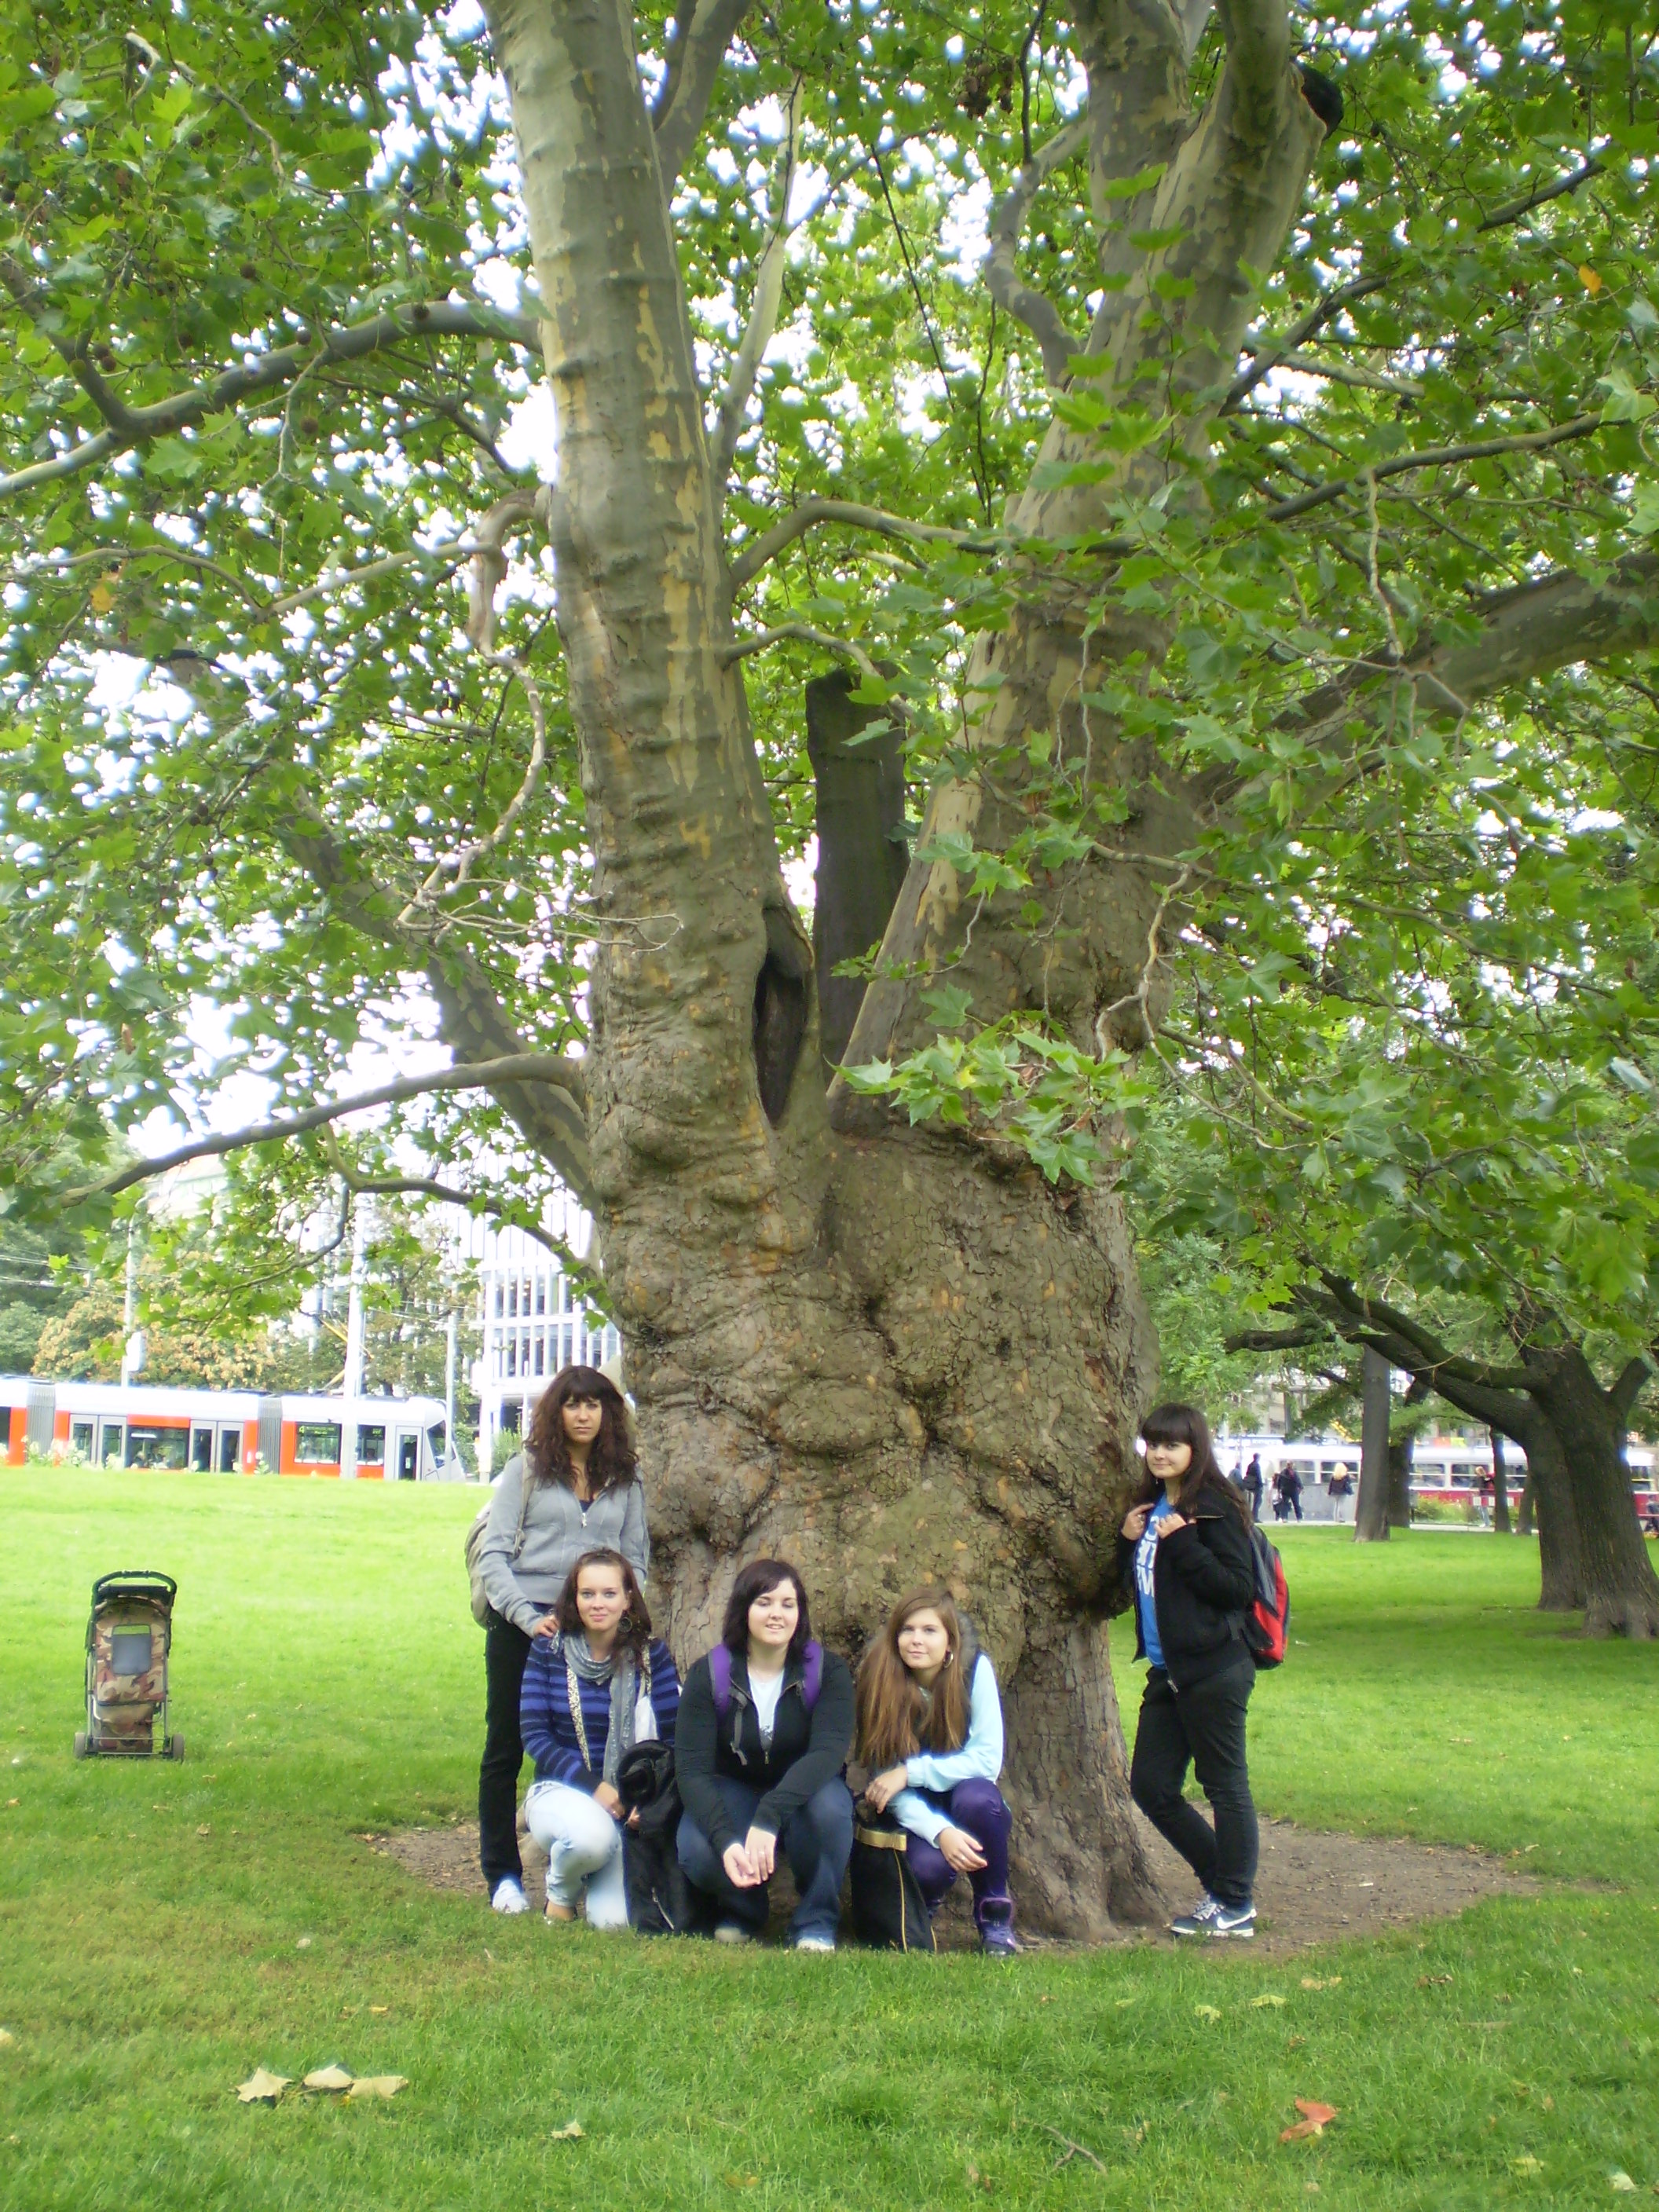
[518,1551,679,1929]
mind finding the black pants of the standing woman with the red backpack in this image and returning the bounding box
[1128,1657,1258,1905]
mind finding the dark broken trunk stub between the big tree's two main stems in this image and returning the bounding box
[808,670,909,1075]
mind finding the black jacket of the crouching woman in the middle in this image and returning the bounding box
[675,1653,851,1858]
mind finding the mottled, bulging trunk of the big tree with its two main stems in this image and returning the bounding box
[487,0,1320,1936]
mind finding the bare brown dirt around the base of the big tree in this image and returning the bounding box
[363,1816,1540,1955]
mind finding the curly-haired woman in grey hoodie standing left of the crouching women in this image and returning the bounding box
[478,1367,650,1914]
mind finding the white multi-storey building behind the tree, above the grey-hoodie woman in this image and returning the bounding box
[458,1199,621,1473]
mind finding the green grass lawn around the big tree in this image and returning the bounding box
[0,1471,1659,2212]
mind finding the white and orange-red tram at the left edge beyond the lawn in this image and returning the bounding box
[0,1376,467,1482]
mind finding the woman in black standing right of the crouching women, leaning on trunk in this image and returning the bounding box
[1117,1404,1256,1938]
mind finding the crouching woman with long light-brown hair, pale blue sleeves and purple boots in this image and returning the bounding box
[859,1586,1020,1957]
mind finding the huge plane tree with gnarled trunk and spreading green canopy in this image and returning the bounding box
[0,0,1659,1933]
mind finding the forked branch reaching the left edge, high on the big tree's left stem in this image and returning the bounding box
[0,285,540,498]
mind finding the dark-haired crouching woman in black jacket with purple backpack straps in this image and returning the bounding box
[675,1559,851,1951]
